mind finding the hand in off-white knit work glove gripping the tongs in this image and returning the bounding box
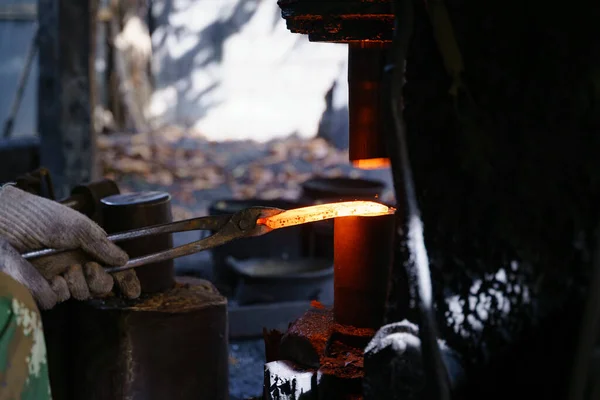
[0,186,140,309]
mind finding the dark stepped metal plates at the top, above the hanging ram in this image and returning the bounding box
[278,0,394,42]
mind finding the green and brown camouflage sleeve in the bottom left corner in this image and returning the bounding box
[0,270,52,400]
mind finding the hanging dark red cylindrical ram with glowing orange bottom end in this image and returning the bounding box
[348,41,390,169]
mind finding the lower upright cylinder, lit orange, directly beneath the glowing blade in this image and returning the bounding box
[333,214,395,329]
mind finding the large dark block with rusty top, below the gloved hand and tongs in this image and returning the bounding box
[69,279,229,400]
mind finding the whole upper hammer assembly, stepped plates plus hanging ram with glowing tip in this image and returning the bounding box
[278,0,394,169]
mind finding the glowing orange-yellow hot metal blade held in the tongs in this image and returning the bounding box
[256,201,396,229]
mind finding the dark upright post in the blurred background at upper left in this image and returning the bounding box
[37,0,97,198]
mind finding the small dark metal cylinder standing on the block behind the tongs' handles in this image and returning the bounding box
[102,192,175,293]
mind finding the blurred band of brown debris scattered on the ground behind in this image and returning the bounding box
[98,127,393,219]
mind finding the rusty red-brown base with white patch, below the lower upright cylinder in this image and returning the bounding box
[263,304,375,400]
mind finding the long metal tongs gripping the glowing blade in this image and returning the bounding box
[22,207,284,273]
